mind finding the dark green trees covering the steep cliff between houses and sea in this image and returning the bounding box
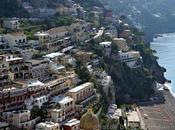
[87,27,158,103]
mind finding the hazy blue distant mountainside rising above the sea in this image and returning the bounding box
[101,0,175,38]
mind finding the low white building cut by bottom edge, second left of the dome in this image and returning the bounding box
[36,122,60,130]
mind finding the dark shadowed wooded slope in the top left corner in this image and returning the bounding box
[0,0,29,17]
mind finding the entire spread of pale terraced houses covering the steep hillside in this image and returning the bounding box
[0,0,146,130]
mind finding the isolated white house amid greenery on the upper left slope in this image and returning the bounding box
[3,19,20,29]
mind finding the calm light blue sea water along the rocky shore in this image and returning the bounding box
[151,33,175,96]
